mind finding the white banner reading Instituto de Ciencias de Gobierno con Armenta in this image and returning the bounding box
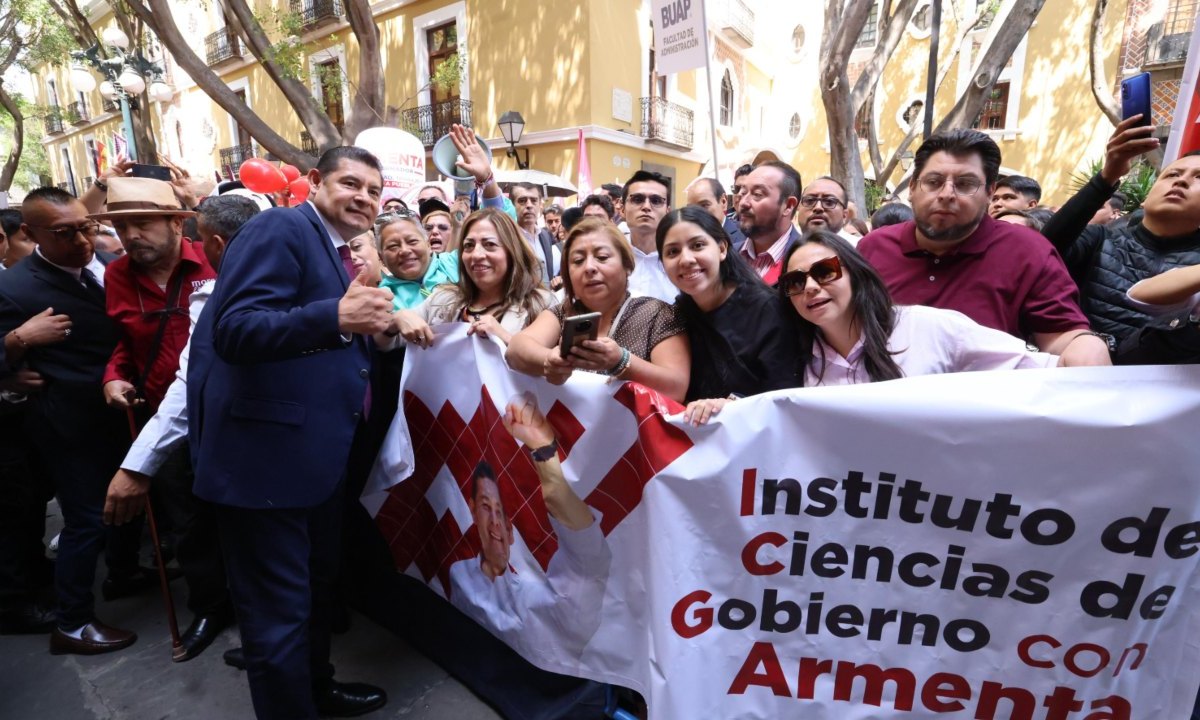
[365,324,1200,720]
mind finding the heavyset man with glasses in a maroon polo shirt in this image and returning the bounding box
[858,130,1111,365]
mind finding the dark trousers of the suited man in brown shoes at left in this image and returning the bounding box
[29,413,130,629]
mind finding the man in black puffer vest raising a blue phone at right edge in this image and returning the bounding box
[1042,118,1200,342]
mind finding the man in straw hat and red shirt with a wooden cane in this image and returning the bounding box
[90,176,226,661]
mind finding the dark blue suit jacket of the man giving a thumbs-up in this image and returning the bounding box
[187,204,371,509]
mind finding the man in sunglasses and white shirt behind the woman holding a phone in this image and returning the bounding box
[620,170,679,302]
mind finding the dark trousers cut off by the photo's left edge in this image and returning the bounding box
[0,407,54,611]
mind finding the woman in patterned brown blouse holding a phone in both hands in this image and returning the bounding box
[505,220,690,401]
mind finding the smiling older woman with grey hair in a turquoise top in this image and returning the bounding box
[374,212,458,310]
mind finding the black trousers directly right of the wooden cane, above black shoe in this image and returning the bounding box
[152,445,229,616]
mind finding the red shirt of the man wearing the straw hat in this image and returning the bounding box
[104,238,217,410]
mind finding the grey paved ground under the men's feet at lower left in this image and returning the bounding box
[0,504,500,720]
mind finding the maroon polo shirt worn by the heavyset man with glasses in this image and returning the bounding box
[858,215,1088,338]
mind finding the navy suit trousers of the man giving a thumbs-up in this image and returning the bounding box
[215,484,344,720]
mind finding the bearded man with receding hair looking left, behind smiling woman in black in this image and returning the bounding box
[738,160,803,286]
